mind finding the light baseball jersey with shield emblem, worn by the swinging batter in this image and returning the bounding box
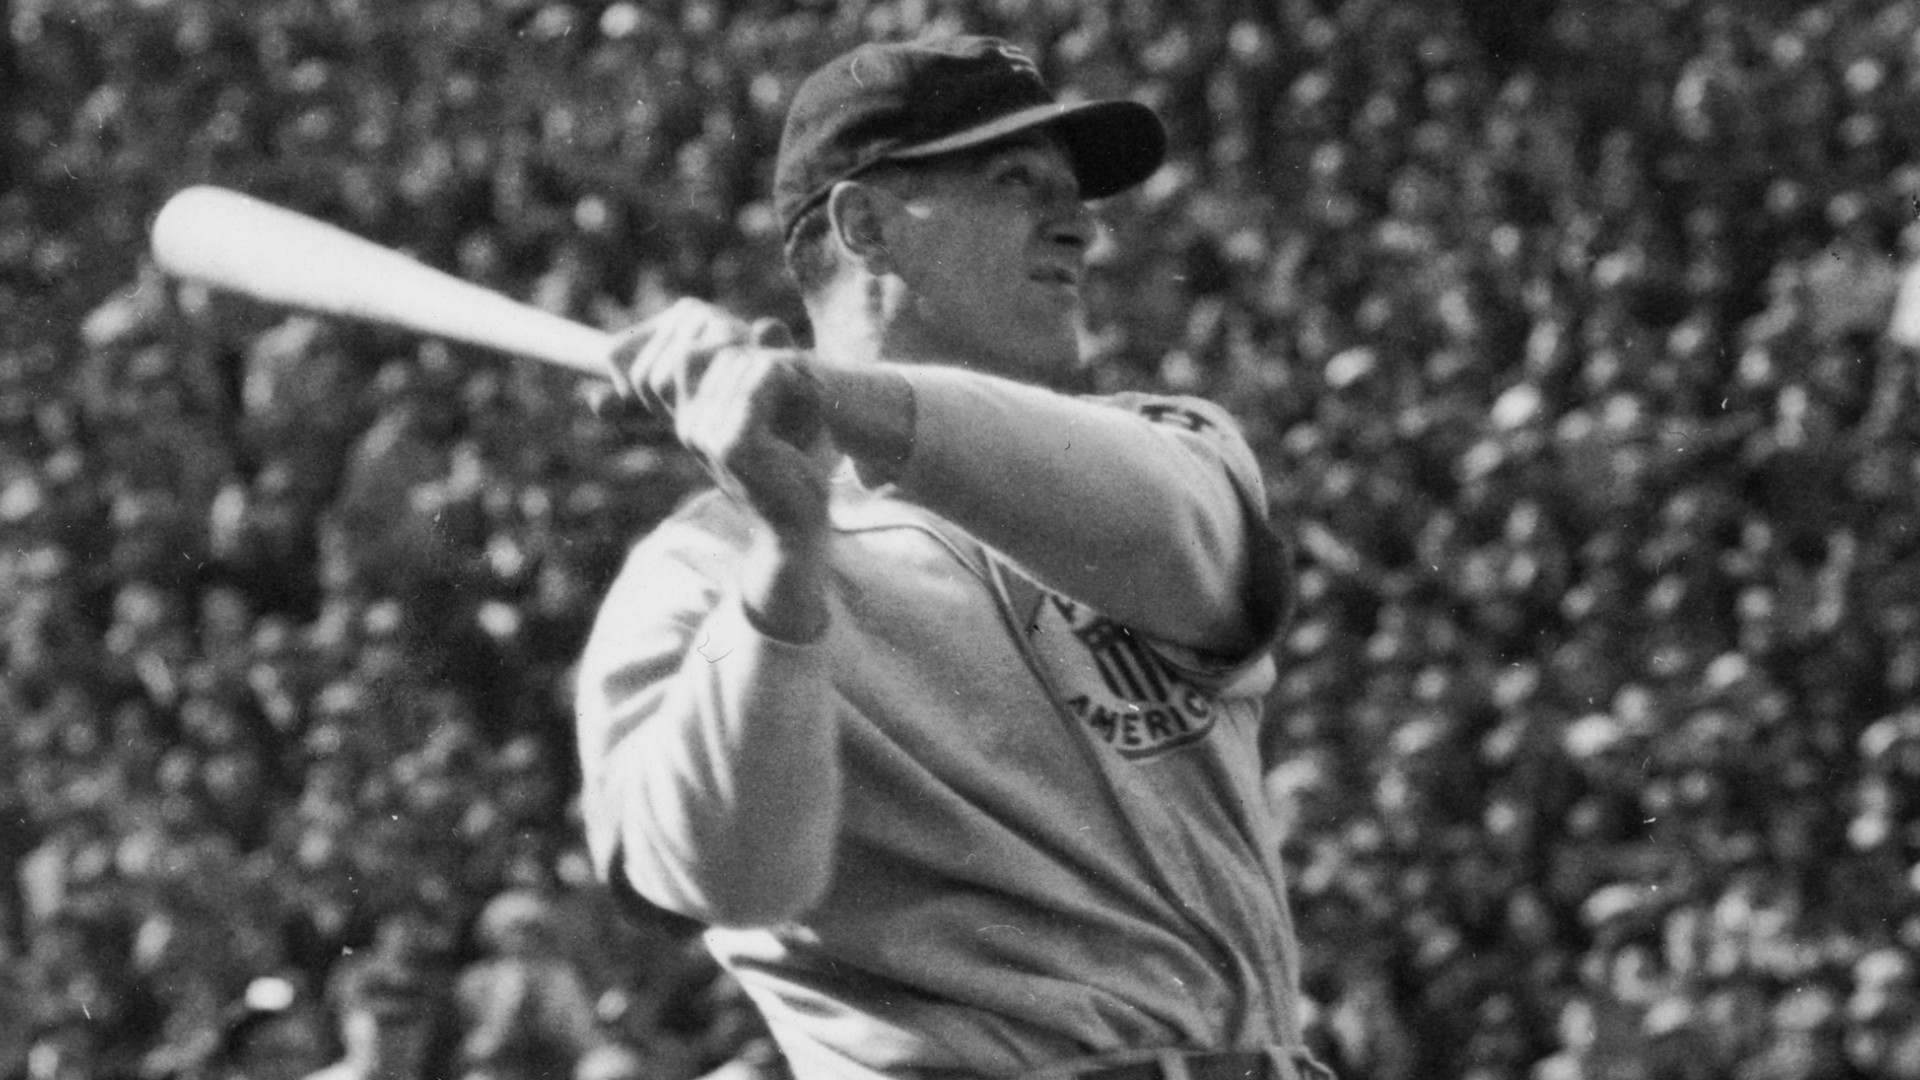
[580,369,1300,1080]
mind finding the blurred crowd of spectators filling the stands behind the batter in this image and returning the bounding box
[11,0,1920,1080]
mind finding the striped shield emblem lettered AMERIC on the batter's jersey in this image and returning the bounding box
[1027,596,1221,761]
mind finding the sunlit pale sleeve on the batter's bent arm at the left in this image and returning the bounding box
[576,500,839,924]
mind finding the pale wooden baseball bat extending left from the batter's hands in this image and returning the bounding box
[152,186,614,379]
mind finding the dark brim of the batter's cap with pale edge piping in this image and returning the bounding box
[885,100,1167,198]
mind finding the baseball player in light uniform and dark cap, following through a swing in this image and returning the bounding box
[578,38,1319,1080]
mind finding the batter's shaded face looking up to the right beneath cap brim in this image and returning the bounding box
[887,136,1092,382]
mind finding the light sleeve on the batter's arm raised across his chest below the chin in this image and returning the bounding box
[899,367,1284,663]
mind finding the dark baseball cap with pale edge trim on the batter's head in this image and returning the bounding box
[774,37,1167,233]
